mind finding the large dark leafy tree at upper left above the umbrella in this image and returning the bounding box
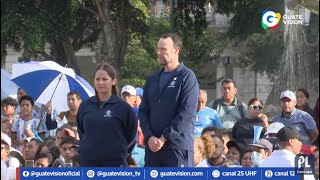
[1,0,100,73]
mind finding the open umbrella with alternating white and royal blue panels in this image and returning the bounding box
[12,61,94,112]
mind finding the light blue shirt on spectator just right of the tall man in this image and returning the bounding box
[194,107,223,137]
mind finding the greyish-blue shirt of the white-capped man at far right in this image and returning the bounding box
[272,109,317,144]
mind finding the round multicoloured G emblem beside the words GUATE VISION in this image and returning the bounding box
[261,10,281,29]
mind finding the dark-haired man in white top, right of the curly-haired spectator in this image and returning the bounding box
[196,135,226,167]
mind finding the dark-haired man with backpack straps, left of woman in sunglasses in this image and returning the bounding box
[212,79,248,129]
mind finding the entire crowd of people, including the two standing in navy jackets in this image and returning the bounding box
[1,34,319,178]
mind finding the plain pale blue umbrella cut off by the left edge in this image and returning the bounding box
[1,68,19,100]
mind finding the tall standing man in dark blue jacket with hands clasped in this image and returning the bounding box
[140,34,199,167]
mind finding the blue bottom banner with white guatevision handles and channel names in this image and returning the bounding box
[13,167,313,180]
